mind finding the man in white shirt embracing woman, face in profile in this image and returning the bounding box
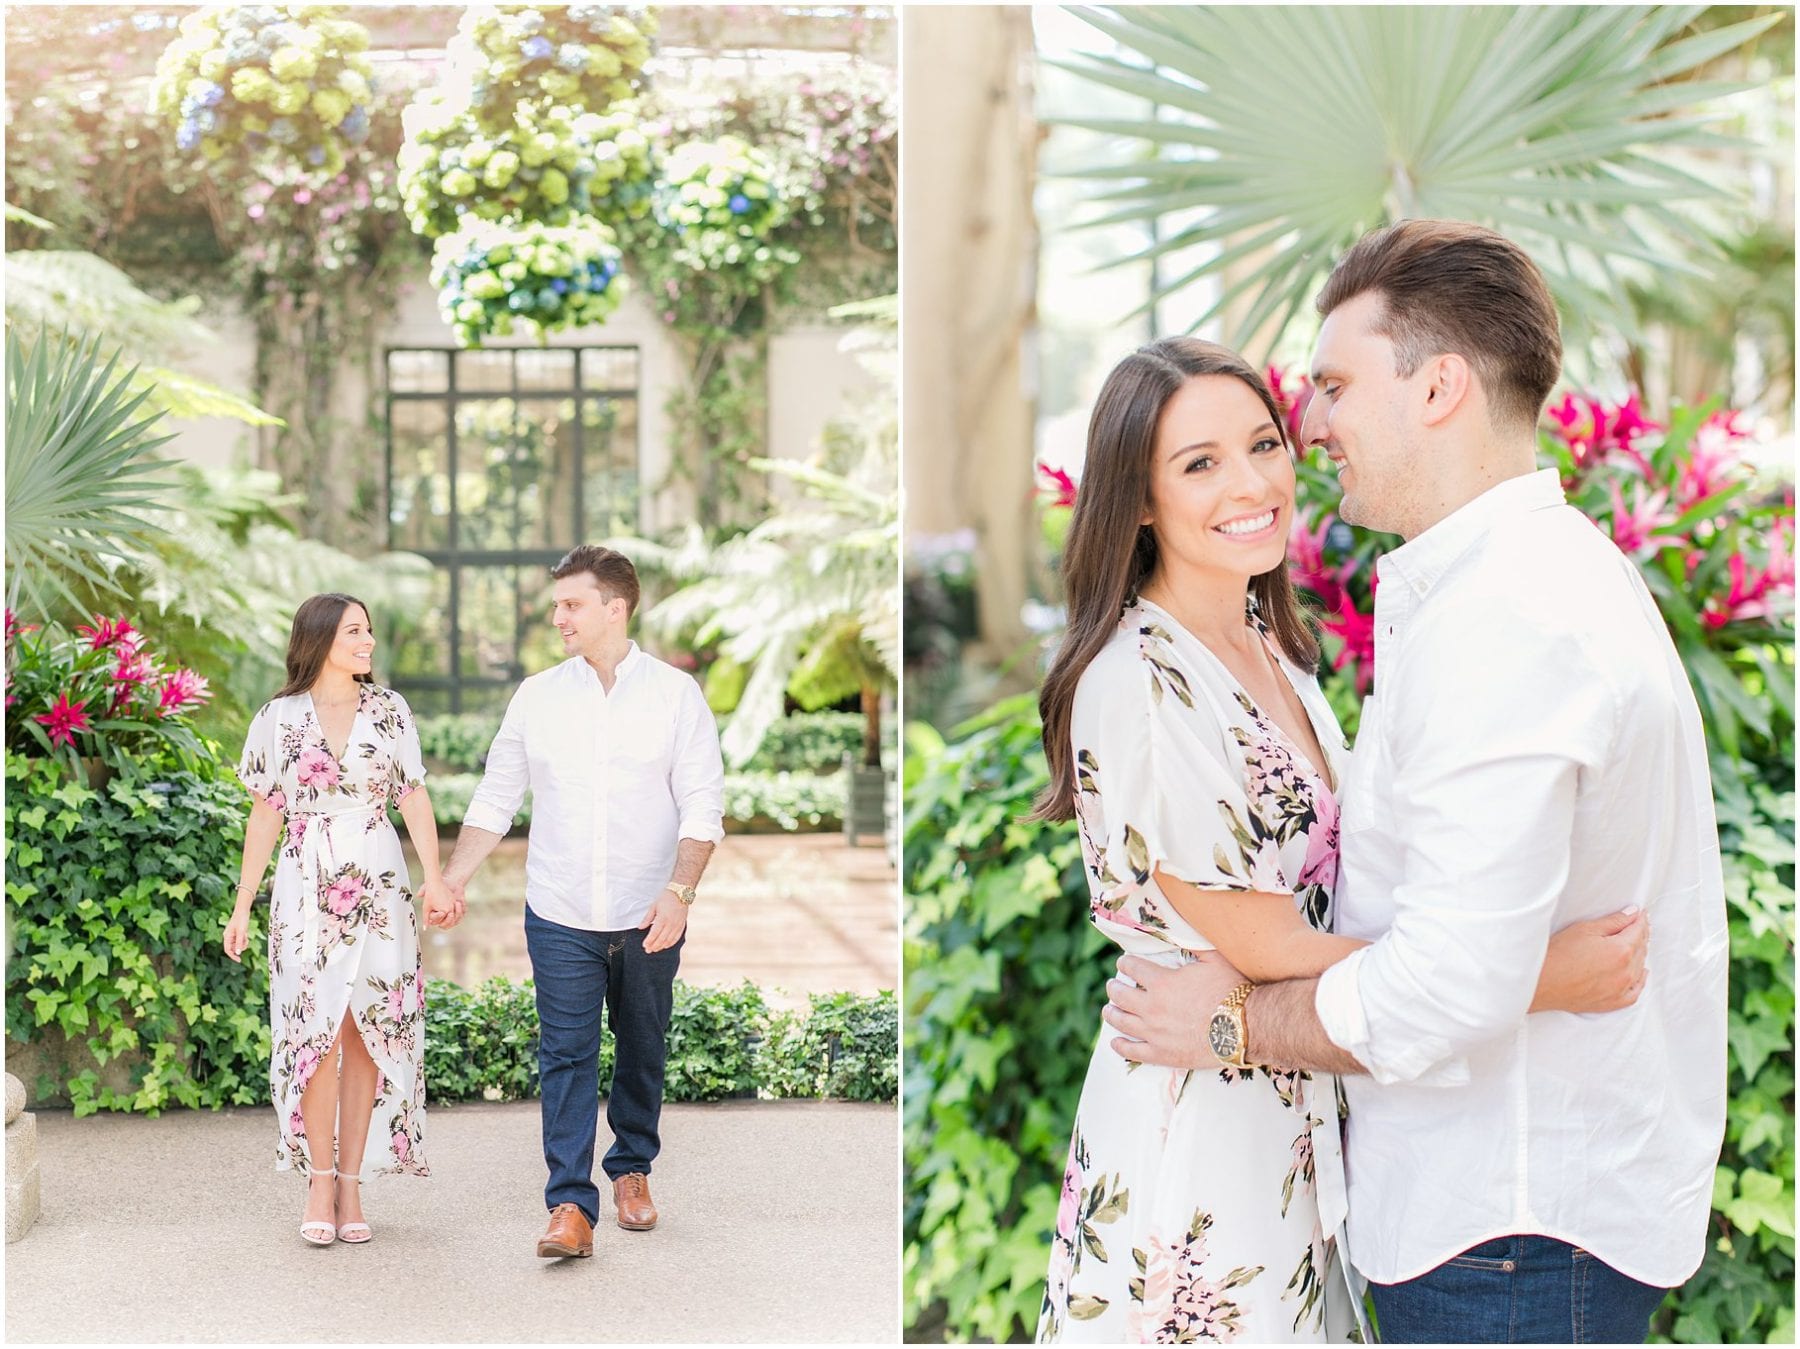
[1107,220,1726,1342]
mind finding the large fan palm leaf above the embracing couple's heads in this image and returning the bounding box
[1051,5,1780,346]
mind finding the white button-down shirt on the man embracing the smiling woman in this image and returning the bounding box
[1316,470,1726,1286]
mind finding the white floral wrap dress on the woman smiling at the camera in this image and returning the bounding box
[1037,600,1357,1344]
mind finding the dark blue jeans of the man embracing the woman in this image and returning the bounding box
[1368,1236,1669,1344]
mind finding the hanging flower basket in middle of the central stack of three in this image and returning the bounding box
[400,95,652,238]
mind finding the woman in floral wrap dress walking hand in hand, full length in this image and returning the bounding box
[225,594,455,1246]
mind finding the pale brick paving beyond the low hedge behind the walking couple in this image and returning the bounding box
[409,834,900,1007]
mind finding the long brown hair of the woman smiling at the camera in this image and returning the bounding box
[1030,337,1319,819]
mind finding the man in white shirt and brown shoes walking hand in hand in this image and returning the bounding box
[445,544,725,1257]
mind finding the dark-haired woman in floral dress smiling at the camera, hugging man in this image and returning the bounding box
[1039,339,1648,1344]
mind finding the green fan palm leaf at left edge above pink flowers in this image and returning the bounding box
[5,328,171,614]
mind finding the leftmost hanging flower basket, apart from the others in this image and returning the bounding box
[151,5,374,180]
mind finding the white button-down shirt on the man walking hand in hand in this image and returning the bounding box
[463,641,725,931]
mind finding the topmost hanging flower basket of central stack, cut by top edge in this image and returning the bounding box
[446,5,657,131]
